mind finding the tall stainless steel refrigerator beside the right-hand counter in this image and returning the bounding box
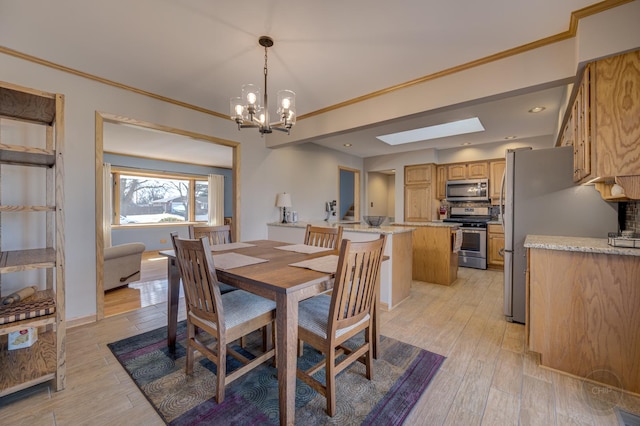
[500,147,618,324]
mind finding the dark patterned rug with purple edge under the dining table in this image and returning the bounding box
[108,321,444,425]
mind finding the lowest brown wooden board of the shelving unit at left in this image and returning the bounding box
[0,331,56,397]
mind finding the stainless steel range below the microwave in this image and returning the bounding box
[444,207,491,269]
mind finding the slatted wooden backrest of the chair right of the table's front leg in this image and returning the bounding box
[328,235,386,337]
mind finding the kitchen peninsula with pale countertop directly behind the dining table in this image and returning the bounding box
[267,221,415,310]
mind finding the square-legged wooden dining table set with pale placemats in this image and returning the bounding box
[160,240,379,425]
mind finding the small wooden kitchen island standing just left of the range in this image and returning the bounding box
[394,221,460,285]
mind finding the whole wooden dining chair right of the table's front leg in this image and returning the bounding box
[297,235,386,417]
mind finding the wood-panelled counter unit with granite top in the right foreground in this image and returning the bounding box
[524,235,640,393]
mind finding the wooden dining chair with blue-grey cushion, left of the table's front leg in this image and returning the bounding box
[171,233,276,404]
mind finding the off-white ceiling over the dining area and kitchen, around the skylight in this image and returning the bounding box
[0,0,598,165]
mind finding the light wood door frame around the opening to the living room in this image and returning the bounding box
[95,111,240,321]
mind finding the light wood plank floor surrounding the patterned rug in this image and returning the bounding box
[0,268,640,426]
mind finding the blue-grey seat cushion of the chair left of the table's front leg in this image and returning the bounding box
[189,290,276,329]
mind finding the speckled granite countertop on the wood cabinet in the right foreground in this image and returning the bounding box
[524,235,640,256]
